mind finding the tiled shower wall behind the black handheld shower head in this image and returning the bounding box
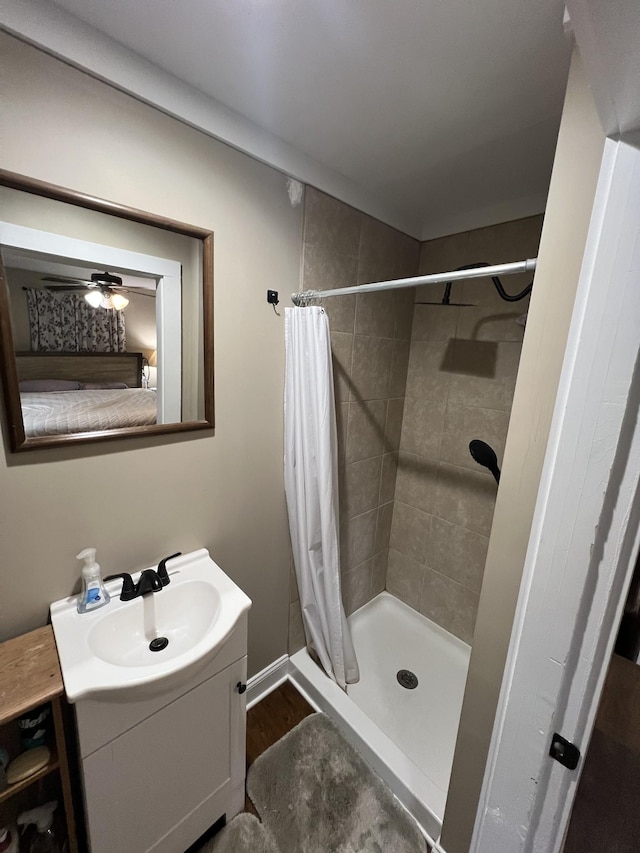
[386,216,542,642]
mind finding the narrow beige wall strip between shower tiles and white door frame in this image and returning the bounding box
[442,52,605,853]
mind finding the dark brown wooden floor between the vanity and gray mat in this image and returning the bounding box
[245,681,314,816]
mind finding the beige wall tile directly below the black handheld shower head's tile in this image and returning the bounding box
[434,462,497,536]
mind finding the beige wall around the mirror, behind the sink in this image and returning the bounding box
[0,34,302,673]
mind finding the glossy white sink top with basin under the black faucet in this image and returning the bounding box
[51,548,251,702]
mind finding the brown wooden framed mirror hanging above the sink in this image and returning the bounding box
[0,170,214,452]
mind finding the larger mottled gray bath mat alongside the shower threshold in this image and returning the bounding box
[248,714,427,853]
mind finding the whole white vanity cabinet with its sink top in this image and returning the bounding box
[51,549,251,853]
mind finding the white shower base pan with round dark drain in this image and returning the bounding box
[289,592,471,841]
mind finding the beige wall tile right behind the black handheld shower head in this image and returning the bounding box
[440,402,509,471]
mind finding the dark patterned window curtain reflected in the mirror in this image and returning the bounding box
[26,287,126,352]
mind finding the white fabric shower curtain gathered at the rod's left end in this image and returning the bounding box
[284,307,360,689]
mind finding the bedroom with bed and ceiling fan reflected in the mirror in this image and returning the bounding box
[2,248,160,438]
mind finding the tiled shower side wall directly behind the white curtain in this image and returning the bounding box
[289,187,420,652]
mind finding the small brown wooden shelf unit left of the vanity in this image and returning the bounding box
[0,625,78,853]
